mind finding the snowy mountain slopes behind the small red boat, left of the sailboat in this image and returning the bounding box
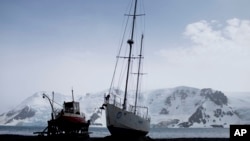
[0,92,103,126]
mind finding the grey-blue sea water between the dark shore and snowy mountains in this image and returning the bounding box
[0,126,229,138]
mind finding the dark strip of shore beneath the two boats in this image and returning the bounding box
[0,134,229,141]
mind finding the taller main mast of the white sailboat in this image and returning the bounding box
[123,0,137,110]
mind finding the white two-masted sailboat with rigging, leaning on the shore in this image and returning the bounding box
[101,0,150,136]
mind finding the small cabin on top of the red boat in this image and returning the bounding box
[63,101,80,115]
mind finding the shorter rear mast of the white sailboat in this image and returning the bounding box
[134,34,144,113]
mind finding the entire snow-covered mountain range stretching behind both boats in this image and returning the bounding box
[0,87,250,127]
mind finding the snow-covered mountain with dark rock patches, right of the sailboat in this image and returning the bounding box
[147,87,250,127]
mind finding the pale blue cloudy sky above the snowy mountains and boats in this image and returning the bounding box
[0,0,250,113]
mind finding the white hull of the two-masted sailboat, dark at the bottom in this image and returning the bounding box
[106,103,150,135]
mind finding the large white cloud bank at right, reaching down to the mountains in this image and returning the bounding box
[154,18,250,90]
